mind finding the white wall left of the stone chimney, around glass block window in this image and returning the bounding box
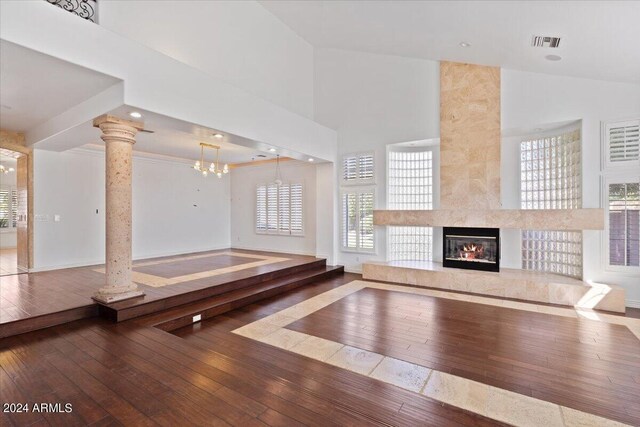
[315,49,440,271]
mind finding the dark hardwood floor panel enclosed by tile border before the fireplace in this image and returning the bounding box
[282,288,640,425]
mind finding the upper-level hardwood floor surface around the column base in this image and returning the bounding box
[0,249,324,337]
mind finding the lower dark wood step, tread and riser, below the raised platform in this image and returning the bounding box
[138,266,344,332]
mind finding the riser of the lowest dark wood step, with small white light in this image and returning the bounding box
[154,269,343,332]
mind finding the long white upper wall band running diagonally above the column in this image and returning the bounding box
[0,0,336,160]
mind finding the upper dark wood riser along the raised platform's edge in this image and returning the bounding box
[108,259,327,322]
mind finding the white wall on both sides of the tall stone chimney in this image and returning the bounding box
[315,49,640,304]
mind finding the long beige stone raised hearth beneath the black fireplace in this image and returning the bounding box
[362,261,625,313]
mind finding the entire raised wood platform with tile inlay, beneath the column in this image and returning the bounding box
[0,250,343,338]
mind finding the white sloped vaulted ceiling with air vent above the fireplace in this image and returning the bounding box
[260,0,640,83]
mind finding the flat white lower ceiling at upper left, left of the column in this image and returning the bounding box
[0,40,119,132]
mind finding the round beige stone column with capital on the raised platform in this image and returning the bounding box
[93,115,144,304]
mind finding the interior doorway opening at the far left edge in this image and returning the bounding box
[0,148,29,276]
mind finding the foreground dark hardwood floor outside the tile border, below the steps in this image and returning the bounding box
[0,274,504,426]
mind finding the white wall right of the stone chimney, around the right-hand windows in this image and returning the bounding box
[501,70,640,305]
